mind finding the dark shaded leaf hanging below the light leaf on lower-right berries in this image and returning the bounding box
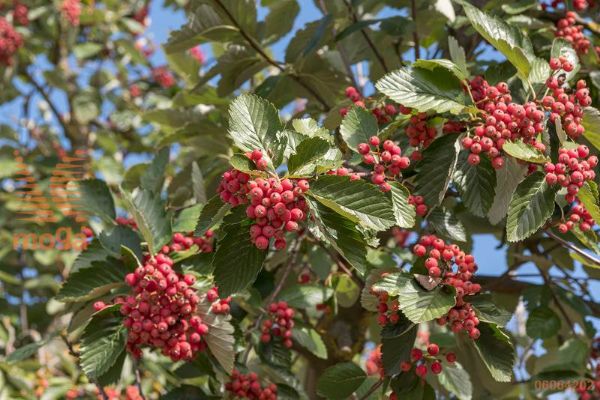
[381,316,419,376]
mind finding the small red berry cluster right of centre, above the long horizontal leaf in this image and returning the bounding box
[358,136,410,192]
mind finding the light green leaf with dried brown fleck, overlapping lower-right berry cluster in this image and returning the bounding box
[398,279,456,324]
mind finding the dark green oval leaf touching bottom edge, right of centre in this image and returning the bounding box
[317,362,367,399]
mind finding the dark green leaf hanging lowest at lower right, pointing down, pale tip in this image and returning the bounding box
[473,323,515,382]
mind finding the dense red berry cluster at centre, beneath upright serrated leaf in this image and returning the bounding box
[217,166,310,250]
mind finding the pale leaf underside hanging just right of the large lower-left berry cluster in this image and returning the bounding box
[198,304,235,373]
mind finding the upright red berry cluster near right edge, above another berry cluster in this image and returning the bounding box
[542,63,592,139]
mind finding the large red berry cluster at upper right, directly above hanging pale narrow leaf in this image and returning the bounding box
[462,76,545,169]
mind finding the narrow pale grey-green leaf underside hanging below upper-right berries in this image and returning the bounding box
[487,157,527,225]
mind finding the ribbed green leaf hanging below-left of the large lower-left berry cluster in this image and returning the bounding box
[79,305,127,380]
